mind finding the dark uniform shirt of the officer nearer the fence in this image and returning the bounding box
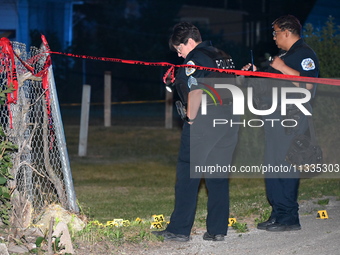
[175,41,235,105]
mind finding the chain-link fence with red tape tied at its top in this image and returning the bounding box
[0,36,78,227]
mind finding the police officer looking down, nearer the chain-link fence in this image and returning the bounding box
[152,22,238,241]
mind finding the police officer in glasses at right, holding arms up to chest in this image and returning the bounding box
[243,15,319,231]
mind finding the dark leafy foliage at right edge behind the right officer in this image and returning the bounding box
[304,17,340,163]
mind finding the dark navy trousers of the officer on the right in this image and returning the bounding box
[264,108,308,225]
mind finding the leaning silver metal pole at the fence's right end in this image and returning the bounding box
[48,65,79,213]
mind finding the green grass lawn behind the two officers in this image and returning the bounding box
[65,126,340,241]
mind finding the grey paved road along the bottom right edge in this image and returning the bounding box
[141,197,340,255]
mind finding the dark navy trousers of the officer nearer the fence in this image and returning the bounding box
[167,107,238,236]
